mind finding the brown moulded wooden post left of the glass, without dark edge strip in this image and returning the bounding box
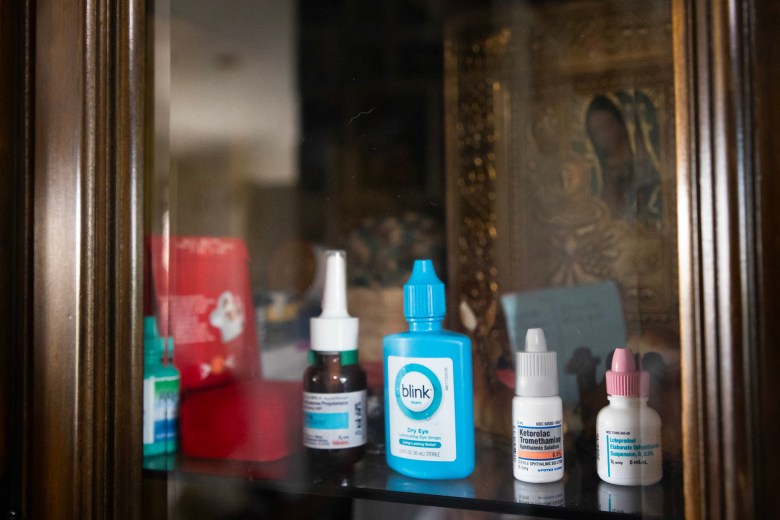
[26,0,145,518]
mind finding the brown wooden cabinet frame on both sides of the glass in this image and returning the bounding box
[0,0,780,519]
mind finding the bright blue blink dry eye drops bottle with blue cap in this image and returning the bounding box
[384,260,474,479]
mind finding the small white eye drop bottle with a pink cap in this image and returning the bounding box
[596,348,663,486]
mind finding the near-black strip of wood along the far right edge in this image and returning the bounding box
[748,0,780,518]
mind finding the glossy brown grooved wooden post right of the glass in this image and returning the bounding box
[674,0,780,518]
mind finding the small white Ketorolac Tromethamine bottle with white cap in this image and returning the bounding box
[512,329,563,483]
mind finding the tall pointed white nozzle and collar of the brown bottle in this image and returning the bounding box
[311,251,358,352]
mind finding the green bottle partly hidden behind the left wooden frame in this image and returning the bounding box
[143,316,180,457]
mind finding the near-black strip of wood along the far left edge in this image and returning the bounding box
[0,0,32,516]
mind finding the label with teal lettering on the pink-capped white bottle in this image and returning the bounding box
[596,428,662,482]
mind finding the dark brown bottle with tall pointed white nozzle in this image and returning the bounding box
[303,251,368,468]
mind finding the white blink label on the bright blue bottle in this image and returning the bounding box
[387,356,457,462]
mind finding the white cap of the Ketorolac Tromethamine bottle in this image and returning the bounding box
[515,329,558,397]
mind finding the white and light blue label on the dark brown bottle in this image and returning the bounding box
[303,390,366,449]
